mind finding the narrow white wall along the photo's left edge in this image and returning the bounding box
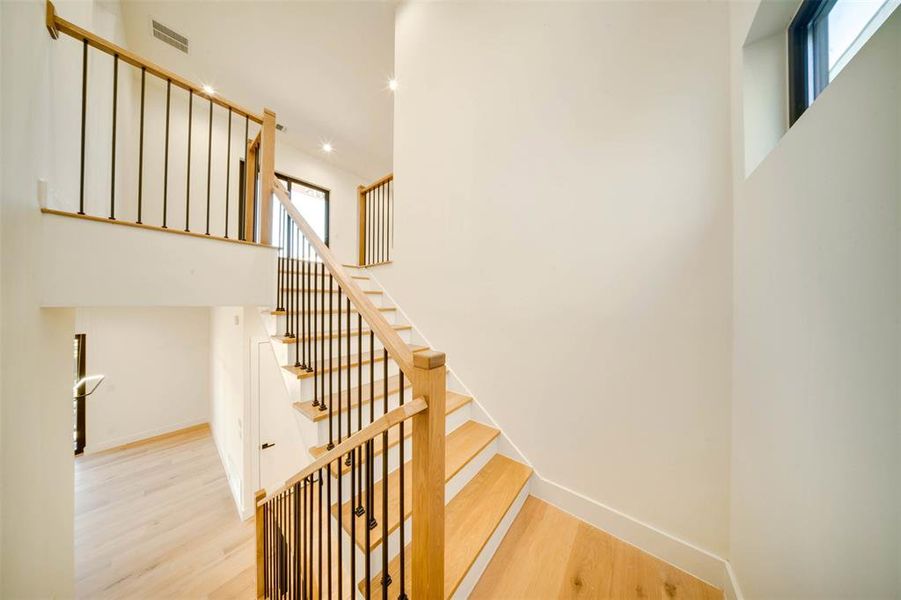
[0,2,109,598]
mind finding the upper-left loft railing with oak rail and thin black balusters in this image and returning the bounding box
[43,2,275,245]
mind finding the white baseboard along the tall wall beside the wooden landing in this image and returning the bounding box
[532,472,742,600]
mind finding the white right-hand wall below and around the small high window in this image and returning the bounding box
[730,5,901,598]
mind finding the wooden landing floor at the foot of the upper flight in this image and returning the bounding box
[470,496,723,600]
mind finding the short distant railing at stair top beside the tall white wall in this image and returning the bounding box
[357,173,394,267]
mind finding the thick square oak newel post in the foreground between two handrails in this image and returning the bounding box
[411,350,447,598]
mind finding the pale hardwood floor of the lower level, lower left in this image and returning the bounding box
[75,426,255,599]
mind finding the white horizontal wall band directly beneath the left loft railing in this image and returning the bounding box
[40,215,276,306]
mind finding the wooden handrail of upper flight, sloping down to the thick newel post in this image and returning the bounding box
[272,177,413,377]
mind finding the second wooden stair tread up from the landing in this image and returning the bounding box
[332,421,500,551]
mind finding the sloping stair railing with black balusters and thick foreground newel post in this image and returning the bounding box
[257,179,446,599]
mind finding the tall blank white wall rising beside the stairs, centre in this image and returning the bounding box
[379,3,732,554]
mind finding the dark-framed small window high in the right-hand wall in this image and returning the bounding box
[788,0,901,125]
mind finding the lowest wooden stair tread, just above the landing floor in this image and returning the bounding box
[359,454,532,598]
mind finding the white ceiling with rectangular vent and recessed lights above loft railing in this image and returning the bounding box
[122,0,394,180]
